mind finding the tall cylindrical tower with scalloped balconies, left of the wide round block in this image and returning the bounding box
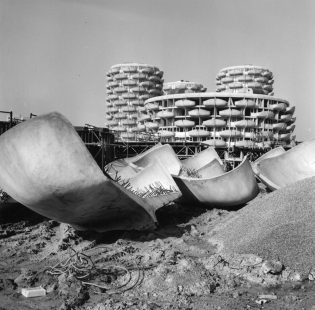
[106,63,163,141]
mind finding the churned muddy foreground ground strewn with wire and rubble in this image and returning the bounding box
[0,187,315,310]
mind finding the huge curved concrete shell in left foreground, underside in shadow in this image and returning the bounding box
[0,112,178,231]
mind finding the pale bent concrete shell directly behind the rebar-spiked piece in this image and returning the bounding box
[132,144,181,175]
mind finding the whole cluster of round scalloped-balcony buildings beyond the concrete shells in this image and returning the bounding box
[107,63,295,167]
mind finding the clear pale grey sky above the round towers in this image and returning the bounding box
[0,0,315,141]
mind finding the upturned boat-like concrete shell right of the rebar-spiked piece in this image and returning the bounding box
[173,157,259,207]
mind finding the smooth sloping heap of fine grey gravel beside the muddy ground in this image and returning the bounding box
[211,177,315,273]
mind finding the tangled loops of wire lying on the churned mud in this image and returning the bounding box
[46,247,142,294]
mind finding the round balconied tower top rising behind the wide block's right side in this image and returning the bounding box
[216,65,274,96]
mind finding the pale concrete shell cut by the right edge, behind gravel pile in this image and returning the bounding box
[256,138,315,191]
